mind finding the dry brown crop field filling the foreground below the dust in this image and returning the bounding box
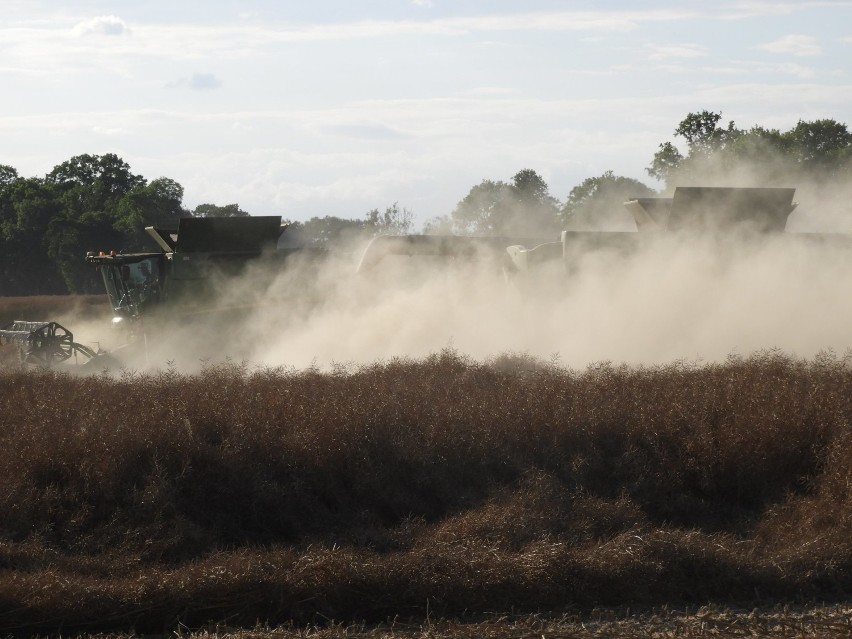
[0,302,852,637]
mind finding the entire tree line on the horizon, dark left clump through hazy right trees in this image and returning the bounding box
[0,111,852,296]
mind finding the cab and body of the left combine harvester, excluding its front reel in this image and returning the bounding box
[80,216,316,362]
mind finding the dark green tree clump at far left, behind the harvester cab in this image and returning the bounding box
[0,153,246,295]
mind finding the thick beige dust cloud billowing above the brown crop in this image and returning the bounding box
[101,205,852,370]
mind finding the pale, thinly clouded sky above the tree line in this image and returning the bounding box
[0,0,852,224]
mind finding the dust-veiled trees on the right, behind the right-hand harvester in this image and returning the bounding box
[440,111,852,237]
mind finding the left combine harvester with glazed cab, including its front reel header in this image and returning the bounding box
[0,216,324,368]
